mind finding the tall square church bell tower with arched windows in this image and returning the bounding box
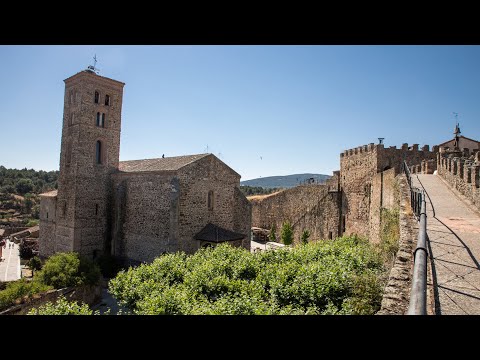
[54,67,125,258]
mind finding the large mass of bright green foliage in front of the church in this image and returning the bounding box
[109,237,384,315]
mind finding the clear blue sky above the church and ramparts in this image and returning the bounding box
[0,45,480,180]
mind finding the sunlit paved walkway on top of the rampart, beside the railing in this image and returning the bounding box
[412,174,480,315]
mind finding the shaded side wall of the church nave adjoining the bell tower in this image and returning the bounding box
[112,172,180,262]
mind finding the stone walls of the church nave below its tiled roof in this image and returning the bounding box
[112,156,251,262]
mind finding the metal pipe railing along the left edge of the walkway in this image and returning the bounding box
[403,161,428,315]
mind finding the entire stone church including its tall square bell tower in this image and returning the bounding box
[39,66,252,263]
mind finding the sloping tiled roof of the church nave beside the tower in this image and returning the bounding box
[118,154,210,172]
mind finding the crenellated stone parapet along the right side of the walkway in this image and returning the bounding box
[437,152,480,209]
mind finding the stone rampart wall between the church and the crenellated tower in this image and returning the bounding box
[250,184,340,242]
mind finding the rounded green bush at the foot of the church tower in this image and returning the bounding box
[36,252,100,289]
